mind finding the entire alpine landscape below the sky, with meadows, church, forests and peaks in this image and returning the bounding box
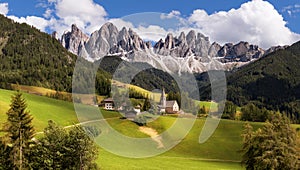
[0,3,300,170]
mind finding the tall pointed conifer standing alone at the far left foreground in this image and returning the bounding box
[3,92,34,169]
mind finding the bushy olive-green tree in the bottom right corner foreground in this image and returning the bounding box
[242,113,300,170]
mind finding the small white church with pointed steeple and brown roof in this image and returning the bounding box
[159,88,179,114]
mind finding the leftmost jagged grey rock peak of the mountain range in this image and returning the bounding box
[61,24,89,55]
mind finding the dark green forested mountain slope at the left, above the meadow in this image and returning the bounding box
[0,15,77,91]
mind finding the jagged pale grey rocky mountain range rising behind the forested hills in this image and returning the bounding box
[60,22,287,73]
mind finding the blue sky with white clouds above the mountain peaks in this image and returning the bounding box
[0,0,300,47]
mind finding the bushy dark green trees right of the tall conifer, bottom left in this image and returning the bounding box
[30,121,99,170]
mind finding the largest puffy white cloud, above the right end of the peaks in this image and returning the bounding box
[189,0,300,48]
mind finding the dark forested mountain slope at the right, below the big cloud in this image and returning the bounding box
[227,42,300,118]
